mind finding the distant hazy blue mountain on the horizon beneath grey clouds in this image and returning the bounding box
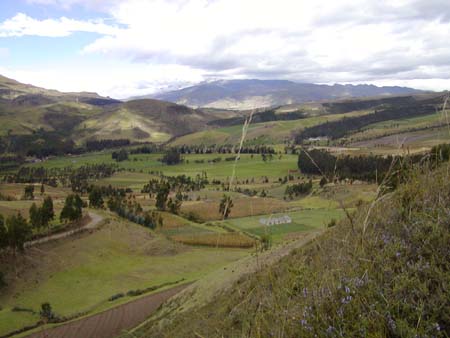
[142,80,420,109]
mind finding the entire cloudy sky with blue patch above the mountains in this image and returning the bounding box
[0,0,450,99]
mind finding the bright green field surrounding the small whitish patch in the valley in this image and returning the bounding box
[223,209,345,242]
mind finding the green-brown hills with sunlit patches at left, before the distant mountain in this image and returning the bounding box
[0,76,235,144]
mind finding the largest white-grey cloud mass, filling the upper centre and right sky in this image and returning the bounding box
[84,0,450,87]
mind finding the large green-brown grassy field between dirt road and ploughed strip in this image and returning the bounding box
[0,220,248,335]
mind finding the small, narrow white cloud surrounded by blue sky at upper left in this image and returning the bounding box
[0,13,119,37]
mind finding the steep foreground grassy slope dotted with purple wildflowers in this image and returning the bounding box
[133,168,450,337]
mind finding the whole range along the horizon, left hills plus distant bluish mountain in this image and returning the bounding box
[0,76,430,145]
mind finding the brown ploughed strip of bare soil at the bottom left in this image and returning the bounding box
[27,283,190,338]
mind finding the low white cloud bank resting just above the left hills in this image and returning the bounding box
[0,63,203,99]
